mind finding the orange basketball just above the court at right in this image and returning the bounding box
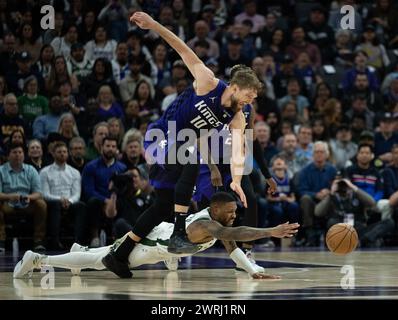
[326,223,358,255]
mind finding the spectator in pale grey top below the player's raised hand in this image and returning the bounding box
[120,56,155,103]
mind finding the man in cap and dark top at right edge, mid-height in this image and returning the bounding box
[375,112,398,164]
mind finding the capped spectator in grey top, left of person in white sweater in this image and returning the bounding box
[66,42,93,81]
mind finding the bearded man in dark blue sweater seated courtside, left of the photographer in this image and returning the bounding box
[82,137,126,247]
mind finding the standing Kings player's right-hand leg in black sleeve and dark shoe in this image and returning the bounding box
[168,163,199,253]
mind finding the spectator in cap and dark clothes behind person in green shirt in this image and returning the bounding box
[7,51,44,96]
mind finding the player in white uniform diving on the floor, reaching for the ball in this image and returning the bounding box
[14,192,299,279]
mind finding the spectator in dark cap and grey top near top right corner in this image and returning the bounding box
[356,24,390,71]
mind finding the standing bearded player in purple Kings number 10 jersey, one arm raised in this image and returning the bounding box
[102,12,262,278]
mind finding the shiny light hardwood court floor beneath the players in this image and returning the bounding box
[0,248,398,300]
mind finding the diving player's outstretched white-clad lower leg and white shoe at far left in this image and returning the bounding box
[14,246,110,278]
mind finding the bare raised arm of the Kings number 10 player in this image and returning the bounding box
[130,12,218,95]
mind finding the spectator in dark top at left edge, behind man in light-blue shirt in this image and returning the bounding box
[0,93,28,148]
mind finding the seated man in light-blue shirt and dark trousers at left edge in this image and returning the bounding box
[0,145,47,252]
